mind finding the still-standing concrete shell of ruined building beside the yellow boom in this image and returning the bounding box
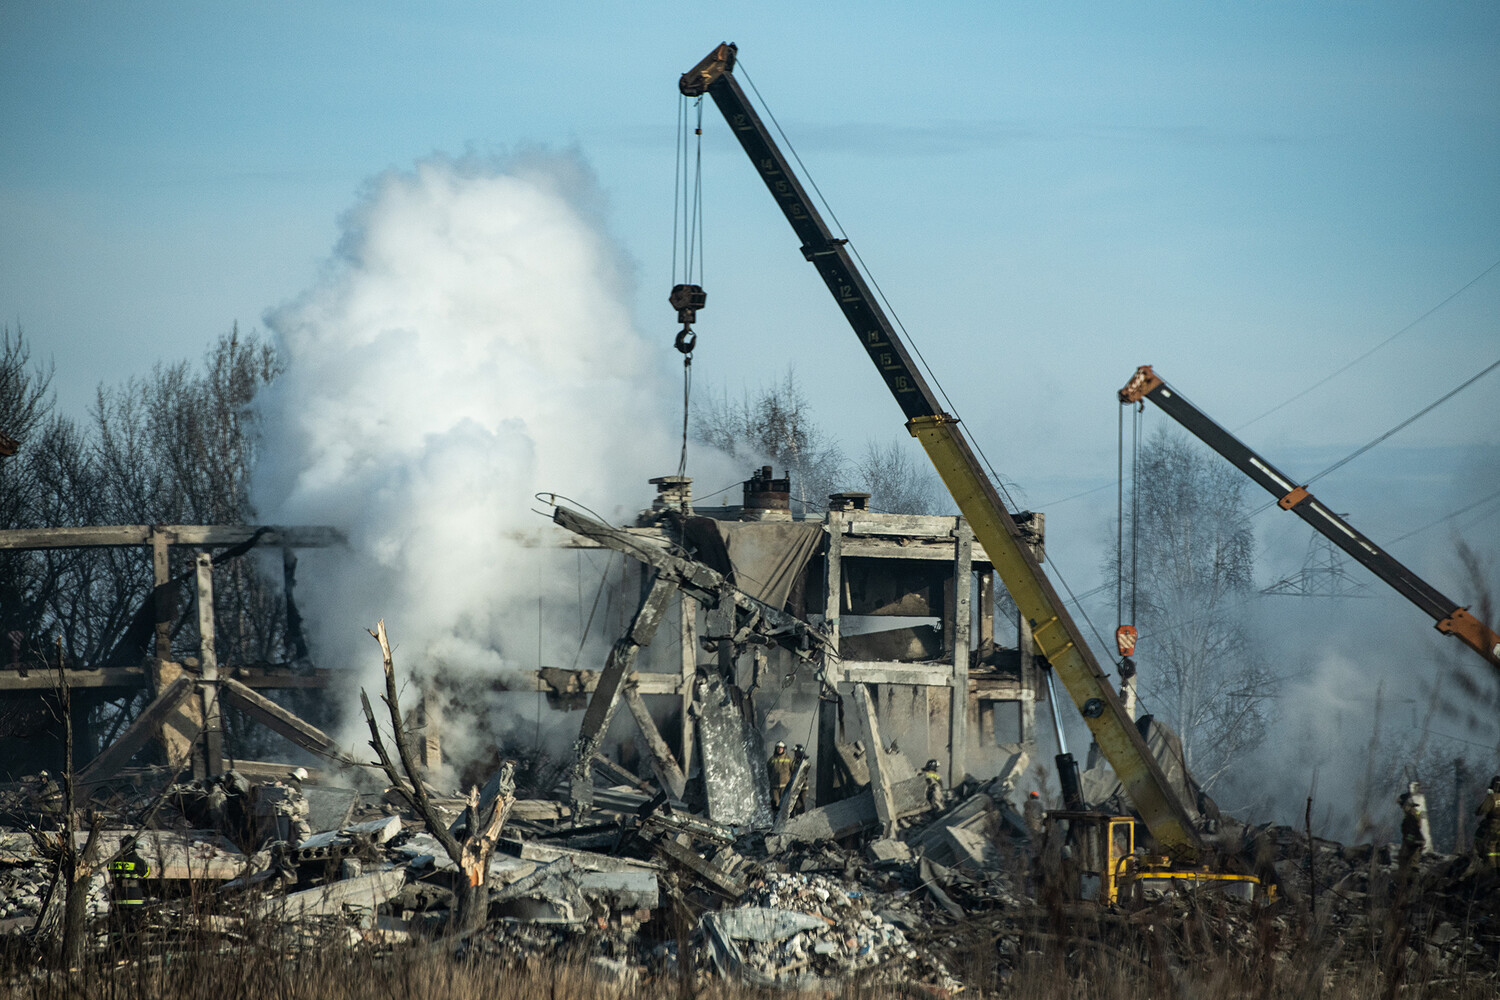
[543,466,1044,822]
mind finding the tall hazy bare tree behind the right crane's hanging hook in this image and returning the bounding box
[1112,429,1277,789]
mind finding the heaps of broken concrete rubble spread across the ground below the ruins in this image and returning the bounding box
[0,758,1500,996]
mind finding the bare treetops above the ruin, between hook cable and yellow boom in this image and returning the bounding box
[693,367,846,510]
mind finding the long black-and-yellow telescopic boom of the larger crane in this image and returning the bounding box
[680,42,1208,865]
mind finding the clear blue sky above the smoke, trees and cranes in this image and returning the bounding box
[0,0,1500,611]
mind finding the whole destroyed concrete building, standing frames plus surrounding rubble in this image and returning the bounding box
[0,469,1500,994]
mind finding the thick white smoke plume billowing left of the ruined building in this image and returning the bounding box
[254,153,678,773]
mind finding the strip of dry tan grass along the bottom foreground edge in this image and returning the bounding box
[0,937,1496,1000]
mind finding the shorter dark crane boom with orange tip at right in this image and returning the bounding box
[1119,364,1500,667]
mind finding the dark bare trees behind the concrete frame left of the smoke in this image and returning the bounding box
[0,328,285,773]
